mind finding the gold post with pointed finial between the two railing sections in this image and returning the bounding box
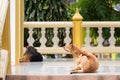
[72,8,83,48]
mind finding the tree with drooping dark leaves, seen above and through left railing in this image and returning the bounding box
[24,0,71,57]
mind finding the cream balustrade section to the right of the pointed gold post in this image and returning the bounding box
[82,21,120,53]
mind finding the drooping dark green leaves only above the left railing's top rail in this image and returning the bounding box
[24,0,71,21]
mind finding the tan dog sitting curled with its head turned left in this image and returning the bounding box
[64,44,99,74]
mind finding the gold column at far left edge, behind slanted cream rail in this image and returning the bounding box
[2,0,11,74]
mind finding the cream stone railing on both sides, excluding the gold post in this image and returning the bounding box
[24,21,120,59]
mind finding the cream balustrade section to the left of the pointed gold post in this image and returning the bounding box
[24,22,72,54]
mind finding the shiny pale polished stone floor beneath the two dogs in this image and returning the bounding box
[12,59,120,75]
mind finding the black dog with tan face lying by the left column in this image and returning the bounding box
[20,46,43,62]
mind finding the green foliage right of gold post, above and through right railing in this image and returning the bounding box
[70,0,120,46]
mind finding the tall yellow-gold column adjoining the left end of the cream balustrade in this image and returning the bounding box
[15,0,24,65]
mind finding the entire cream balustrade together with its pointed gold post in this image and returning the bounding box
[20,10,120,58]
